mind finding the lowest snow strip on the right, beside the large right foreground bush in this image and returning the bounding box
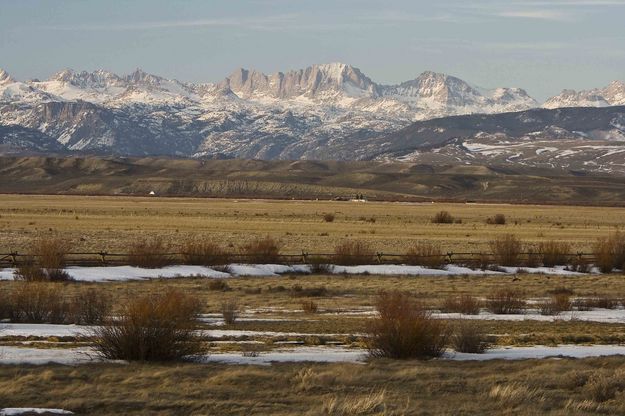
[443,345,625,361]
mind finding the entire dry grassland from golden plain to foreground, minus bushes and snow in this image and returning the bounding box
[0,195,625,415]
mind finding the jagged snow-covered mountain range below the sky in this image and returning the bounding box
[0,63,625,173]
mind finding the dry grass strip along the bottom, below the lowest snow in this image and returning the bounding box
[0,358,625,415]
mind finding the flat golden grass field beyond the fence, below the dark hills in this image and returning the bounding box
[0,195,625,254]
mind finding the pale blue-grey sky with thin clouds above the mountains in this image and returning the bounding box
[0,0,625,100]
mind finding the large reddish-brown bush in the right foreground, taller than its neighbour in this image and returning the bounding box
[367,292,448,359]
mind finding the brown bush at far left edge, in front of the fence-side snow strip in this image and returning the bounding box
[7,282,70,324]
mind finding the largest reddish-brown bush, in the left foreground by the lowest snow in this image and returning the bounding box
[93,290,206,361]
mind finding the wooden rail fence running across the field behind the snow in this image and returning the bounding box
[0,250,595,267]
